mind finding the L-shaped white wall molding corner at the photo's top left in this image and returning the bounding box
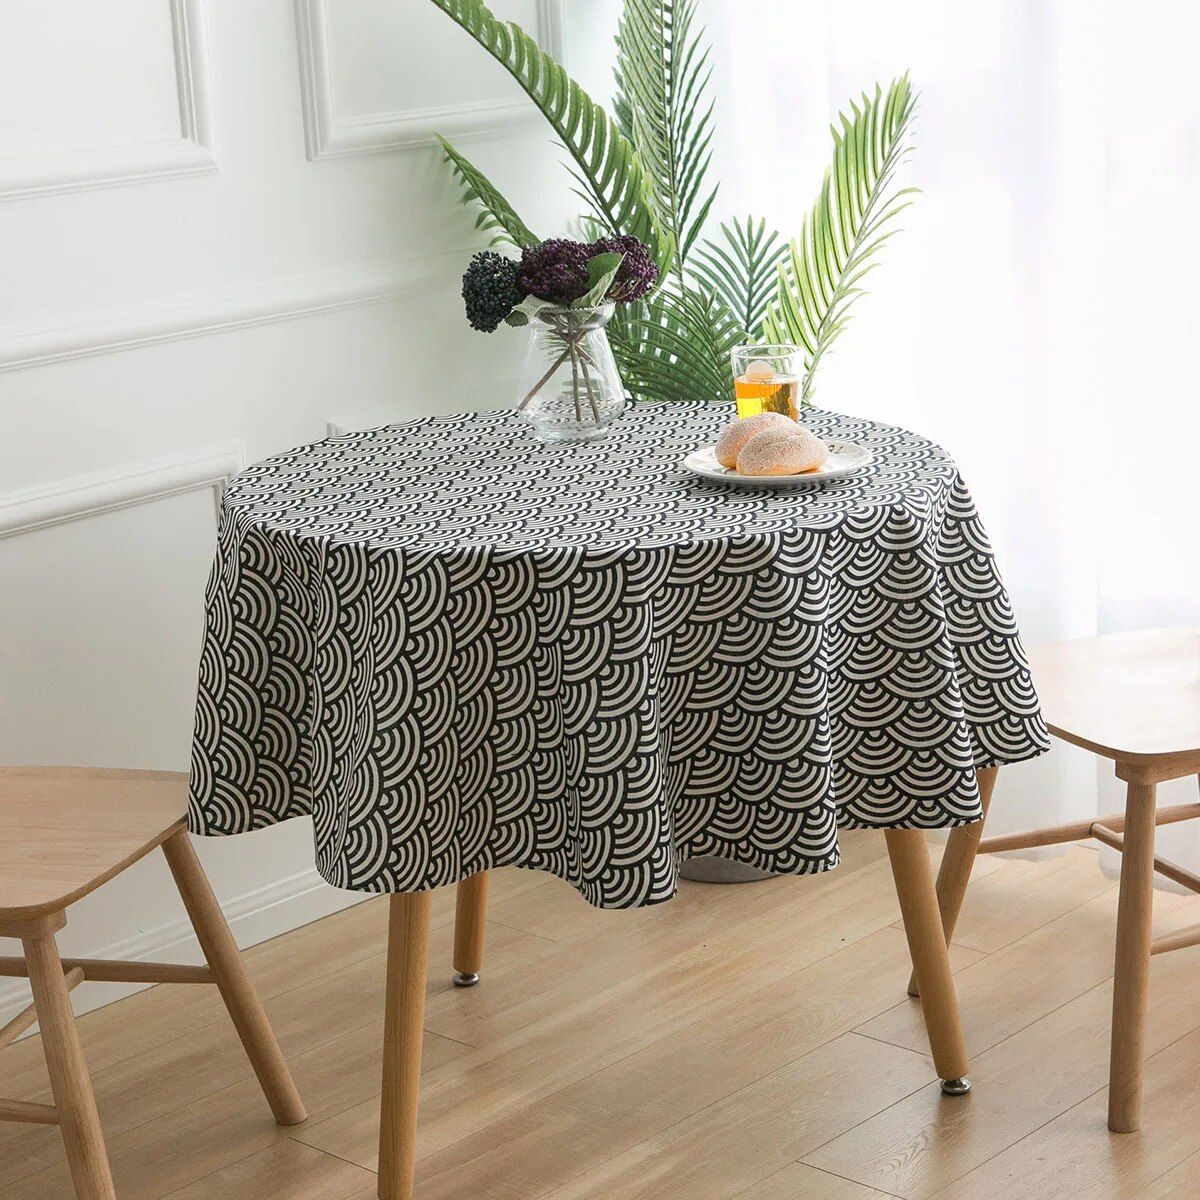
[0,0,217,199]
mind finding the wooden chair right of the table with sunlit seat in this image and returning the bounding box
[908,629,1200,1133]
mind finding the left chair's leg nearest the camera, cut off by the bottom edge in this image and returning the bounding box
[23,932,116,1200]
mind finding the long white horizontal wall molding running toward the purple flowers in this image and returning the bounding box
[0,258,463,372]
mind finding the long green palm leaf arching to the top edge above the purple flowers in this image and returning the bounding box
[433,0,674,272]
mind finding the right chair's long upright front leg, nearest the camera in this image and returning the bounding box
[1109,784,1154,1133]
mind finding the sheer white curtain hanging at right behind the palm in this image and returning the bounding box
[571,0,1200,844]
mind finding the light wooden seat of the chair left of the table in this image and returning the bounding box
[0,767,187,923]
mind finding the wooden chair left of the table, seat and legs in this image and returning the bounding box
[0,767,305,1200]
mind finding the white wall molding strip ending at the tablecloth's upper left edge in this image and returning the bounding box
[0,442,246,539]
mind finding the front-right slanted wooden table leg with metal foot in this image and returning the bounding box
[884,829,971,1096]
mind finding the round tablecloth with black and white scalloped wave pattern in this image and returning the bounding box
[190,404,1049,907]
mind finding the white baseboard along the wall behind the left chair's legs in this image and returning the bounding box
[0,868,371,1026]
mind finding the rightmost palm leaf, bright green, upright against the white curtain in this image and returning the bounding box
[763,74,917,400]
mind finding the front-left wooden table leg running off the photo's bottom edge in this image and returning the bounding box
[379,892,432,1200]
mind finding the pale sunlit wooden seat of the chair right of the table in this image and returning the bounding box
[1030,629,1200,762]
